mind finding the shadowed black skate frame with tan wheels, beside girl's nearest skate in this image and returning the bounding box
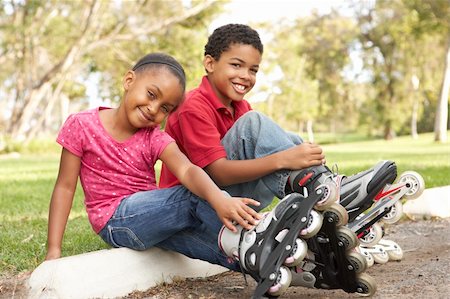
[291,205,376,296]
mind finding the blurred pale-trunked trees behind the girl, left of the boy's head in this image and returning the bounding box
[0,0,220,140]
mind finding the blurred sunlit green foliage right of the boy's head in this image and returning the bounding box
[255,0,450,139]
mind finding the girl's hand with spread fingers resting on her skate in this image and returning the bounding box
[214,197,262,232]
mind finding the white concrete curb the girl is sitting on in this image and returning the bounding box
[28,248,227,299]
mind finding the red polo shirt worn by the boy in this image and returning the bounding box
[159,76,251,188]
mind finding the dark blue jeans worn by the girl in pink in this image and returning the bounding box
[99,186,239,271]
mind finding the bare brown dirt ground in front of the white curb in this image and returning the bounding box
[0,219,450,299]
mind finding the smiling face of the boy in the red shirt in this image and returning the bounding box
[203,44,262,106]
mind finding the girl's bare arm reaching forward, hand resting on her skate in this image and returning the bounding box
[160,142,261,231]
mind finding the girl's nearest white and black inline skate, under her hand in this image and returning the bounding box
[218,185,338,298]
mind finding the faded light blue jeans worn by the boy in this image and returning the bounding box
[222,111,303,209]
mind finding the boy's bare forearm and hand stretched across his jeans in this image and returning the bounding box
[205,143,325,186]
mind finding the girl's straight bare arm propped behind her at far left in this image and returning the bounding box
[45,148,81,260]
